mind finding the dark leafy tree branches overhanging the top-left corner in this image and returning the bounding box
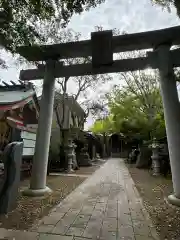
[0,0,104,52]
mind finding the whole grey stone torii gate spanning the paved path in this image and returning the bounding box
[18,26,180,206]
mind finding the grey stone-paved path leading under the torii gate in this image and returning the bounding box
[0,158,158,240]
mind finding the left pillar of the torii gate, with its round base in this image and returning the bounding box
[24,60,55,196]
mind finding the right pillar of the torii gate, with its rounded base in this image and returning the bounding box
[156,45,180,206]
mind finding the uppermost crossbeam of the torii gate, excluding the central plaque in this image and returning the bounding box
[17,26,180,61]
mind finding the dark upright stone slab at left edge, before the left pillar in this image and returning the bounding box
[0,142,23,214]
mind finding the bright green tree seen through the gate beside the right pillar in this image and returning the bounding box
[91,67,165,140]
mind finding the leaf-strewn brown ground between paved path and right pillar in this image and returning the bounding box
[127,165,180,240]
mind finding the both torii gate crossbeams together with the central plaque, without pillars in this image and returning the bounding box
[18,26,180,80]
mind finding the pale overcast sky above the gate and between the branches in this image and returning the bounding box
[0,0,180,126]
